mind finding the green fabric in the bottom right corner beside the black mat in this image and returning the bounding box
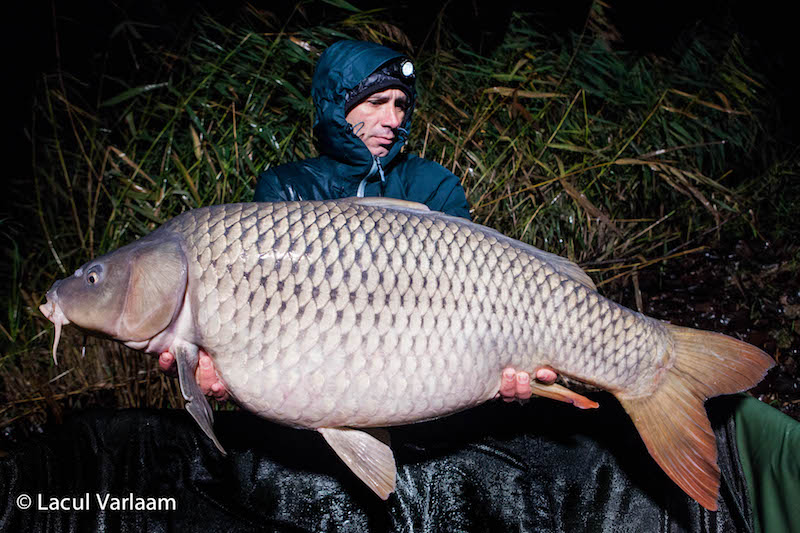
[736,395,800,533]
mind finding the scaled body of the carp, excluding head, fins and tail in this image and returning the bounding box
[159,202,667,427]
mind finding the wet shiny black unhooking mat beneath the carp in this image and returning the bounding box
[0,393,752,533]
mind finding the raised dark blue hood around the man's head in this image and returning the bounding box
[311,41,415,179]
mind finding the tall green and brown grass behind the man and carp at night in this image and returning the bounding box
[0,3,780,432]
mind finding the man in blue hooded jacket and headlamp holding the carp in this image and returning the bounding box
[159,41,556,401]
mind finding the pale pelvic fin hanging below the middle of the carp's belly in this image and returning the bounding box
[318,428,397,500]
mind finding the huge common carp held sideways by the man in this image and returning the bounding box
[41,198,774,510]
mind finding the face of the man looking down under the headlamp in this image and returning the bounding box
[345,89,408,157]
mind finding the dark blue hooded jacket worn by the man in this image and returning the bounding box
[254,41,470,218]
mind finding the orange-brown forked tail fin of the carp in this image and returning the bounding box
[618,324,775,511]
